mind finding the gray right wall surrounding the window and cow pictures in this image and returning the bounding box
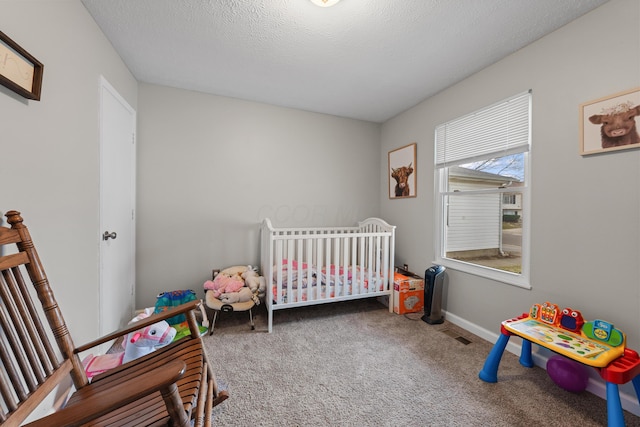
[380,0,640,348]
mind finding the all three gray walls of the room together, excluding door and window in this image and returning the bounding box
[0,0,640,410]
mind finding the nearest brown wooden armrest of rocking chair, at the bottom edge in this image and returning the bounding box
[27,359,188,427]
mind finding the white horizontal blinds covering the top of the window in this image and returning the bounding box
[435,91,531,168]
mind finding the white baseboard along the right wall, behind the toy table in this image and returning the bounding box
[444,312,640,417]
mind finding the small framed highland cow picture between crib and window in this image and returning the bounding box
[387,142,418,199]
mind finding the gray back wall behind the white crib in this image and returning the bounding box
[136,84,380,307]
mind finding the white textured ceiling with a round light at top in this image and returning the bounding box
[82,0,607,122]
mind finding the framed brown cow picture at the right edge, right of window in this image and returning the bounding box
[580,87,640,156]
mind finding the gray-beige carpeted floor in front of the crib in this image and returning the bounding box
[205,299,640,427]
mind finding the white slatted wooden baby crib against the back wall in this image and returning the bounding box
[260,218,396,332]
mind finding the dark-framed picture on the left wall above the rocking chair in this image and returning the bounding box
[0,31,44,101]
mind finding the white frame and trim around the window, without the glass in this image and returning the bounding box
[434,91,532,289]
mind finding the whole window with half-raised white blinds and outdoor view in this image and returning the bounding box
[435,91,531,288]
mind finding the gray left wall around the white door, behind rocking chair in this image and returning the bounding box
[0,0,137,344]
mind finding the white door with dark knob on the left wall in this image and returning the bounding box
[99,78,136,335]
